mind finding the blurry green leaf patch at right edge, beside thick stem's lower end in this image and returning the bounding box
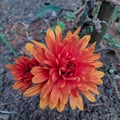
[104,34,120,48]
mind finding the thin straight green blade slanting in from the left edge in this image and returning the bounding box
[0,34,18,57]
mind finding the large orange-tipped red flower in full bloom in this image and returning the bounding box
[24,26,104,112]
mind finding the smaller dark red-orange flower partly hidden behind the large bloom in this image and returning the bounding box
[6,56,38,92]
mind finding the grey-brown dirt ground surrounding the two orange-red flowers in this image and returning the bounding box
[0,0,120,120]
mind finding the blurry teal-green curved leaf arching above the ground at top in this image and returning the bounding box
[37,5,61,18]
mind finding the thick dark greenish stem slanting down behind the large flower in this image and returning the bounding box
[91,1,115,47]
